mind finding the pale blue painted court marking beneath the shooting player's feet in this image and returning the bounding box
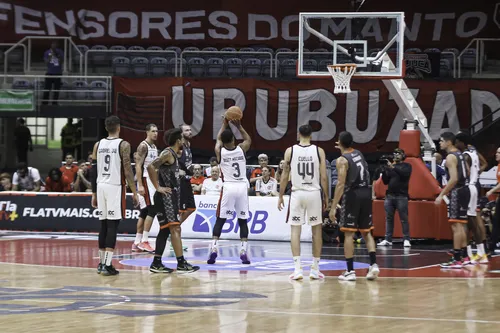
[120,257,370,272]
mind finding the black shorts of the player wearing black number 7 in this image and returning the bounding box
[339,188,373,232]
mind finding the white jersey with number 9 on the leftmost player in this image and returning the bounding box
[97,138,123,185]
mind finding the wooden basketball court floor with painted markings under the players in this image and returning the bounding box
[0,234,500,333]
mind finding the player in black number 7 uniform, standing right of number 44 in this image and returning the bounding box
[329,132,380,281]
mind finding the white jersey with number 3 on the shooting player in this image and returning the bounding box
[220,146,247,183]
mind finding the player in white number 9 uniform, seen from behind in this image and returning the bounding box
[92,116,138,276]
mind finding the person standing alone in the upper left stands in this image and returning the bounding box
[43,41,64,105]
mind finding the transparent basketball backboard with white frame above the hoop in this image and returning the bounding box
[297,12,405,79]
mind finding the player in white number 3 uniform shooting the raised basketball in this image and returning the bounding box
[207,107,252,264]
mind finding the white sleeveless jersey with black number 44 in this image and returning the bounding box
[290,145,321,191]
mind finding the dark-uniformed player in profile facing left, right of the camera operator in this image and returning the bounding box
[435,132,470,269]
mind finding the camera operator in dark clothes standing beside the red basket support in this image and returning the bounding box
[378,148,412,247]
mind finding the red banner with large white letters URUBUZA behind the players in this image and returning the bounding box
[114,78,500,153]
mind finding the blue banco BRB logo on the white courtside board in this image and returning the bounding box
[193,201,269,234]
